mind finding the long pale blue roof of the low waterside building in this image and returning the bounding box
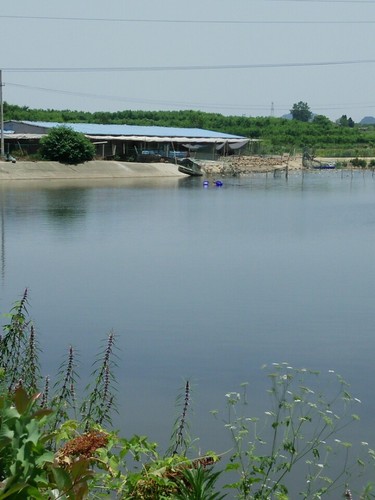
[22,121,245,139]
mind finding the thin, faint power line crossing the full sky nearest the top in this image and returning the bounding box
[0,14,375,24]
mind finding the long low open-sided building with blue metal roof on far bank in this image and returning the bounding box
[4,120,250,161]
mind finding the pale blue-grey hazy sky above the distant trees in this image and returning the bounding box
[0,0,375,122]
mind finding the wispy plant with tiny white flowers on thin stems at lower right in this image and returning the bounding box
[219,363,373,499]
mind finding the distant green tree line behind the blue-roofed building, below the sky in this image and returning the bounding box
[4,101,375,156]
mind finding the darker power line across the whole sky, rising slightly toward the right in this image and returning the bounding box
[2,59,375,73]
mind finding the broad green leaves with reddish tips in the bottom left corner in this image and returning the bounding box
[0,387,93,500]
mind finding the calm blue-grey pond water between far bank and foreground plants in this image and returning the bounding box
[0,172,375,494]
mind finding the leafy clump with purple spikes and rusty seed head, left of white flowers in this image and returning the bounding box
[0,290,223,500]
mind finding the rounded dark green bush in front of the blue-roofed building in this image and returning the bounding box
[40,126,95,165]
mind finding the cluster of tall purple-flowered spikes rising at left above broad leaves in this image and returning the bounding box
[0,289,116,444]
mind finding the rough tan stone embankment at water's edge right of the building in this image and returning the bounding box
[199,155,302,175]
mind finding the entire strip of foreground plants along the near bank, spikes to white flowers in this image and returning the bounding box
[0,291,375,500]
